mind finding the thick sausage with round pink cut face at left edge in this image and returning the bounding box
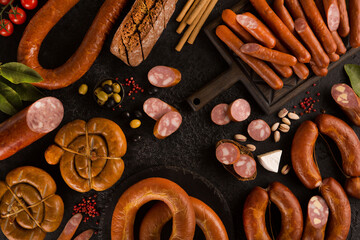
[0,97,64,160]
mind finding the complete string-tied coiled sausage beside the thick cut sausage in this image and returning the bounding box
[45,118,127,192]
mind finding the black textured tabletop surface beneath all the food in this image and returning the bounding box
[0,0,360,239]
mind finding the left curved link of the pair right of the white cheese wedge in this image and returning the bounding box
[291,121,321,189]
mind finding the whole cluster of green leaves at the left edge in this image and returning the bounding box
[0,62,43,115]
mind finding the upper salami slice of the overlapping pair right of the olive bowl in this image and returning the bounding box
[143,98,177,121]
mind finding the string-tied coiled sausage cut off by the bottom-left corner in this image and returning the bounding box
[0,166,64,240]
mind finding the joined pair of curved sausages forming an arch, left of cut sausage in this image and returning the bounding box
[243,182,303,240]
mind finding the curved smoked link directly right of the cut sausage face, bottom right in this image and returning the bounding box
[320,177,351,240]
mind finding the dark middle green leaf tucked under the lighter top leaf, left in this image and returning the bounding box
[0,76,44,101]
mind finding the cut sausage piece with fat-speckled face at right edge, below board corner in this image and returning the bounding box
[331,83,360,126]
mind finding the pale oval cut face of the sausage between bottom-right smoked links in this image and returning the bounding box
[308,196,329,229]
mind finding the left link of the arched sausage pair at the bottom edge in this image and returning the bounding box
[243,187,271,240]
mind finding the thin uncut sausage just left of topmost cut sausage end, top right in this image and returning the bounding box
[300,0,337,53]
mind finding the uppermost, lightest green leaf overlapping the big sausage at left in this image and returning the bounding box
[0,62,43,84]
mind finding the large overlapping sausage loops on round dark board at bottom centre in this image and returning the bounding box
[111,178,228,240]
